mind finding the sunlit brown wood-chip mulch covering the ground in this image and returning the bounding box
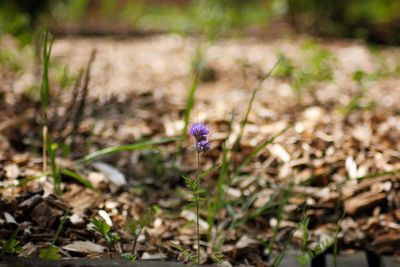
[0,34,400,264]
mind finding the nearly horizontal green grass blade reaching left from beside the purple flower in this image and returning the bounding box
[75,137,180,164]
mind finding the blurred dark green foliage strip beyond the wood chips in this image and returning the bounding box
[0,0,400,45]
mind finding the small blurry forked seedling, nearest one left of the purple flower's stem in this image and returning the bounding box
[125,208,155,257]
